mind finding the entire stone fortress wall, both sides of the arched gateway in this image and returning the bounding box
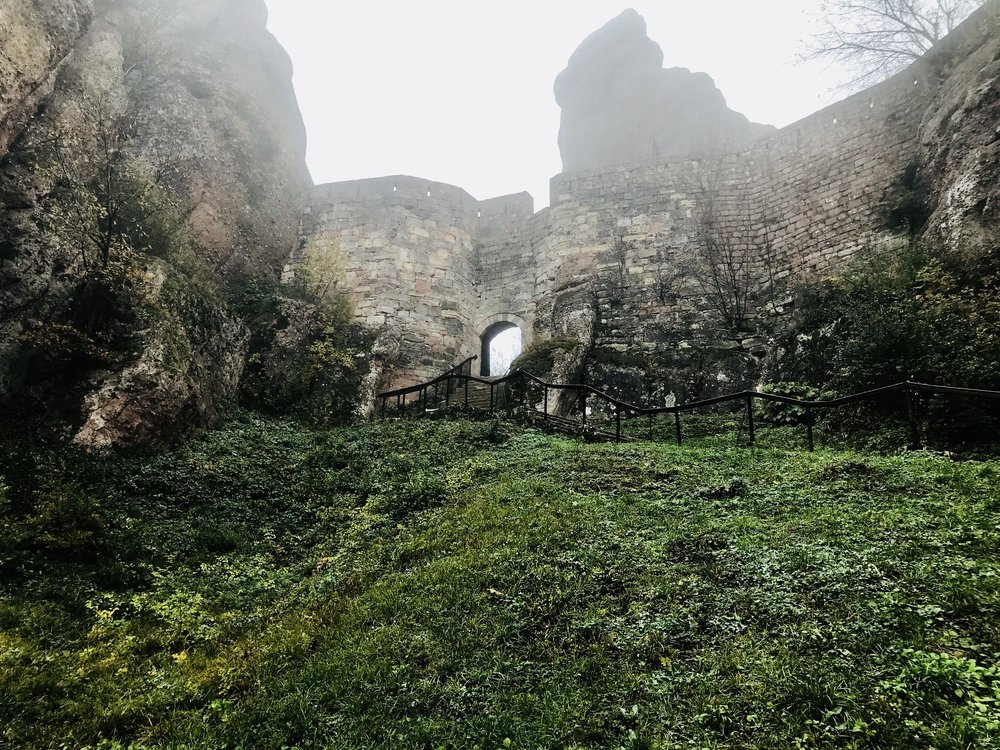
[300,2,1000,394]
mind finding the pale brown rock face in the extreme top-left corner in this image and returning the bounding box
[0,0,93,157]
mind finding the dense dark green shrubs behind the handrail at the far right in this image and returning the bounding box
[777,243,1000,442]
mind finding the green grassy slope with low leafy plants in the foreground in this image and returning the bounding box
[0,415,1000,750]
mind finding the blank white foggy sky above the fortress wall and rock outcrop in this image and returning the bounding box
[267,0,839,209]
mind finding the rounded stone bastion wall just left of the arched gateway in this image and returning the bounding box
[298,176,479,385]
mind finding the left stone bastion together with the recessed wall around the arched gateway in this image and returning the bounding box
[298,181,548,387]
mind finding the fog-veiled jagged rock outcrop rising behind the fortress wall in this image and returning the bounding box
[555,10,774,172]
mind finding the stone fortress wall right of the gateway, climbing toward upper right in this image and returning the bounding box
[535,60,933,350]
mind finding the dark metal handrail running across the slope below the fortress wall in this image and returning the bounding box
[378,368,1000,451]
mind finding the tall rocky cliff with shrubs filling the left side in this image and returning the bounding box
[0,0,311,446]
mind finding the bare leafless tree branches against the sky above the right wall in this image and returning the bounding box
[801,0,984,91]
